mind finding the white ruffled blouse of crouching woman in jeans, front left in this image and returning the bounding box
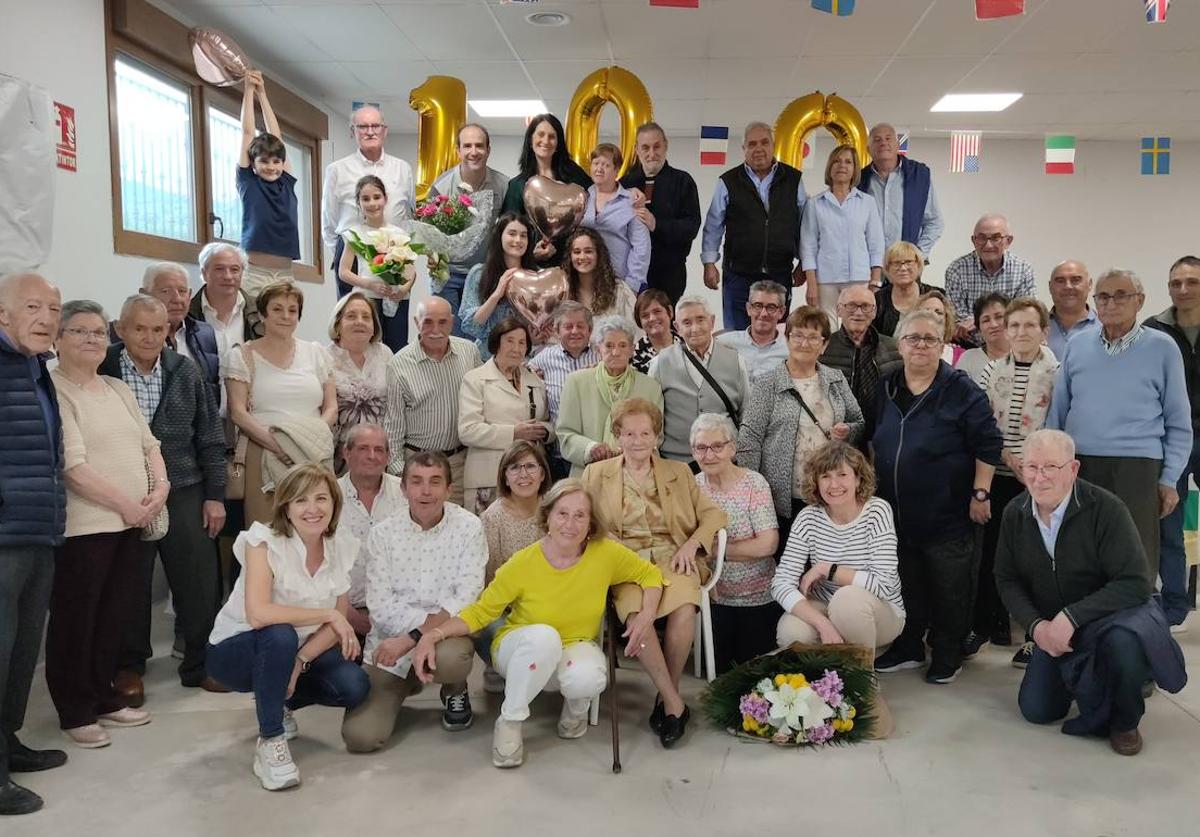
[209,523,359,645]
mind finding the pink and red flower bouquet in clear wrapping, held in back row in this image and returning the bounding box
[404,183,496,290]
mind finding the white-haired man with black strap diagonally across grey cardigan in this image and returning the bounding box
[649,296,750,462]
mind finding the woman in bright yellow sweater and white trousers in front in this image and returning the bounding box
[413,480,683,767]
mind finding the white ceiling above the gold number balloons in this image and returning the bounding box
[160,0,1200,139]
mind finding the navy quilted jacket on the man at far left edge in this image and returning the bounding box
[0,336,67,547]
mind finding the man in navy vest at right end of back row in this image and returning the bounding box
[858,122,946,260]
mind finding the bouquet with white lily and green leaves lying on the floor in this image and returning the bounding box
[703,646,876,747]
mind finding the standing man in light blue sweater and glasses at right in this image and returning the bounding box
[1046,270,1192,579]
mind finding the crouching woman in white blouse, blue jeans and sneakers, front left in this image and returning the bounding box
[208,465,370,790]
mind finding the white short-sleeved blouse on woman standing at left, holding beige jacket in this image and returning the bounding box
[221,339,334,424]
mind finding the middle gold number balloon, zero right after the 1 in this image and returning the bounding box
[566,66,654,177]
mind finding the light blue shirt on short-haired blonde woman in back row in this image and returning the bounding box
[800,188,883,284]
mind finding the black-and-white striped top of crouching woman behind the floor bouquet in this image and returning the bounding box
[770,496,905,618]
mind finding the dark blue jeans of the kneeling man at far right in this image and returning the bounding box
[1016,628,1151,733]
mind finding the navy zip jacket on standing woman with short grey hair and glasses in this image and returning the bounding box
[871,361,1004,543]
